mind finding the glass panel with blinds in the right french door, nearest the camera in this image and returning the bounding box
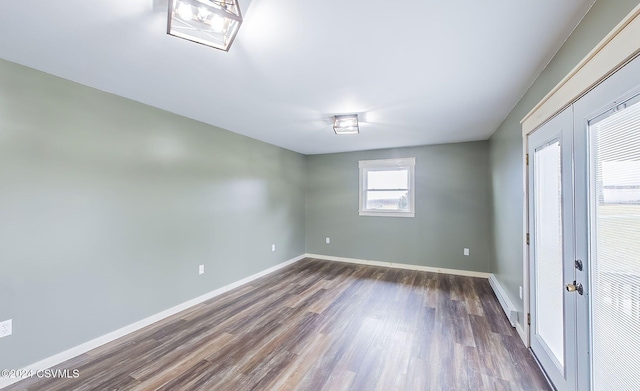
[589,99,640,390]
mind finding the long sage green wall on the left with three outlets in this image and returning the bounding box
[0,60,306,369]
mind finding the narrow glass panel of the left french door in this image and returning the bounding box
[534,141,564,373]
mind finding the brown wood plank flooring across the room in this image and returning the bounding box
[6,259,550,391]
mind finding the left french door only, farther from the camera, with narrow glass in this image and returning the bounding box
[528,107,577,390]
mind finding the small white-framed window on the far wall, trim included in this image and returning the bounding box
[359,157,416,217]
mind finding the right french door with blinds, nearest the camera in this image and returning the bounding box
[574,52,640,391]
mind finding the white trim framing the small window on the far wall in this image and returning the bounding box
[358,157,416,217]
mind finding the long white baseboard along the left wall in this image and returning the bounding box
[0,255,306,389]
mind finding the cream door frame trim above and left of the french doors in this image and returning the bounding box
[516,4,640,347]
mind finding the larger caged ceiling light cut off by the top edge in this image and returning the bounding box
[167,0,242,51]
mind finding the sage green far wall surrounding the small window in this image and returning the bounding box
[306,141,492,272]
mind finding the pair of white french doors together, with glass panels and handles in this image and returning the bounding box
[527,53,640,391]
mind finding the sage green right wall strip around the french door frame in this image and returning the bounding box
[490,0,640,330]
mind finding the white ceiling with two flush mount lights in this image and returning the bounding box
[0,0,595,154]
